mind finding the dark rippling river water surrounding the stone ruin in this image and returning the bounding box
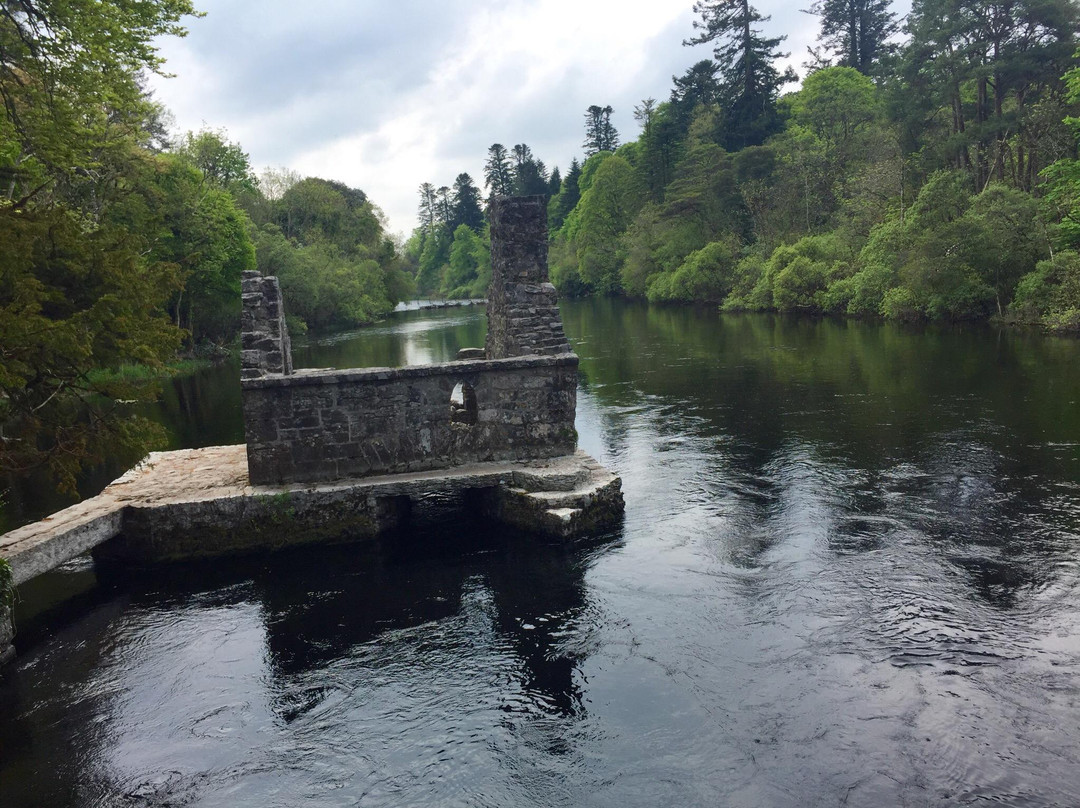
[0,301,1080,808]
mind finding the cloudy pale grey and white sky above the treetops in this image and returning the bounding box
[153,0,909,234]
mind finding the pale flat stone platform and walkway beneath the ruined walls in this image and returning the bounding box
[0,444,623,663]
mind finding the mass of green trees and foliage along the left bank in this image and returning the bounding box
[0,0,411,489]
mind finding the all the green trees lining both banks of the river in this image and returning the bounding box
[0,0,1080,489]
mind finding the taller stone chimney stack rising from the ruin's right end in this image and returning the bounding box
[485,196,570,359]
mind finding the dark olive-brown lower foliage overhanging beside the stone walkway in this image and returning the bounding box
[0,208,179,489]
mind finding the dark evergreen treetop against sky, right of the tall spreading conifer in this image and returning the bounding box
[807,0,897,76]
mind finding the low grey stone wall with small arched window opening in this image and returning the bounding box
[243,353,578,485]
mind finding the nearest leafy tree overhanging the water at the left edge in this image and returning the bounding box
[0,0,192,488]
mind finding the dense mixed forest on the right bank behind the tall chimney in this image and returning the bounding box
[407,0,1080,332]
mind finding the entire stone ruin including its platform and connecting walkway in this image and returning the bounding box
[0,197,623,662]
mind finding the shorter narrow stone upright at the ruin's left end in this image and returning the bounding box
[240,270,293,379]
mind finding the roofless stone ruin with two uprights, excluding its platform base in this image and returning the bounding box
[242,197,591,485]
